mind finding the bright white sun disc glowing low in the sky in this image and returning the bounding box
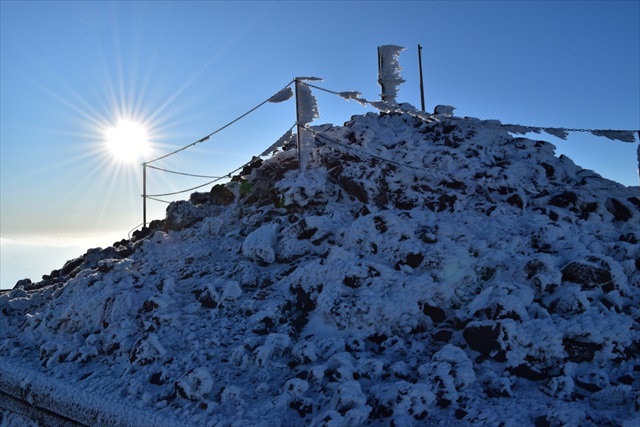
[105,120,150,163]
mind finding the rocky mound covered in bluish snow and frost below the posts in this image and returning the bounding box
[0,113,640,426]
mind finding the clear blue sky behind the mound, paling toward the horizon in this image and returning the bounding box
[0,0,640,287]
